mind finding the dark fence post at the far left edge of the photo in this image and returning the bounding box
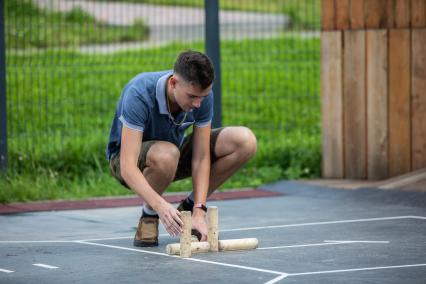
[0,0,7,172]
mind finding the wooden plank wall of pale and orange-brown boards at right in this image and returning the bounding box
[321,0,426,179]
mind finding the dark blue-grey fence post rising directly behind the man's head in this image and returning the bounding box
[204,0,222,128]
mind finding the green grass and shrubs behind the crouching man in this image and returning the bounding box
[0,0,321,202]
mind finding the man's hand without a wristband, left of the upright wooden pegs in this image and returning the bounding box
[155,201,183,236]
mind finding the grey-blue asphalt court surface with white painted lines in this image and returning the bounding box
[0,182,426,284]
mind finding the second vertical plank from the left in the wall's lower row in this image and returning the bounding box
[343,31,367,179]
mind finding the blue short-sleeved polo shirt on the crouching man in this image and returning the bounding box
[106,70,213,160]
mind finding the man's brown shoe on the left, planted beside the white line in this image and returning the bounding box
[133,216,158,247]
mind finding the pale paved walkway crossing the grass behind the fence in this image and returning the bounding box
[35,0,290,53]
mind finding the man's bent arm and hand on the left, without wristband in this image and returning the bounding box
[120,126,182,236]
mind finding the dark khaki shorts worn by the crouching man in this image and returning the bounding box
[109,128,223,188]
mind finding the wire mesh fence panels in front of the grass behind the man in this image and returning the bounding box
[4,0,320,176]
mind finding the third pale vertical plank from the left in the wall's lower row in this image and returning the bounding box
[366,30,388,179]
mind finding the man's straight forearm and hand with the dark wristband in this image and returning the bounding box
[192,125,211,241]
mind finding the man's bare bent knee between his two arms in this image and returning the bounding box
[146,141,180,174]
